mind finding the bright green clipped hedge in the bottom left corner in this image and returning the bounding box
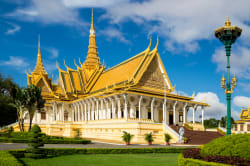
[0,151,22,166]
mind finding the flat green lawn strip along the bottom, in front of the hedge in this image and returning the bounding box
[21,153,179,166]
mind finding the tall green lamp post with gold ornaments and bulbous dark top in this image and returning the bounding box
[214,17,242,135]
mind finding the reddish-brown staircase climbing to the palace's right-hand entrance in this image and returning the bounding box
[169,125,223,145]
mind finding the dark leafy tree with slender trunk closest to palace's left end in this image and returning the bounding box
[24,85,45,131]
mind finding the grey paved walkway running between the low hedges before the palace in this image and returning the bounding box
[0,142,198,150]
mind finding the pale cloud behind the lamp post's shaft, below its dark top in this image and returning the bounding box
[212,46,250,79]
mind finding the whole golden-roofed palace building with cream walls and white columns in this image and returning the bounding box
[19,10,208,143]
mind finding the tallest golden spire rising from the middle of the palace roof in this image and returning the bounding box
[83,8,100,70]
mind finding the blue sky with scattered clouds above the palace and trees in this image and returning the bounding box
[0,0,250,119]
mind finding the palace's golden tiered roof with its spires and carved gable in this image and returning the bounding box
[27,10,208,106]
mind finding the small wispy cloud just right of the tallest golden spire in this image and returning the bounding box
[99,27,130,44]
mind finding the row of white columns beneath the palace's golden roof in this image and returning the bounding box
[48,94,204,125]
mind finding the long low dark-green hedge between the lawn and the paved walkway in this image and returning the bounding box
[9,148,187,158]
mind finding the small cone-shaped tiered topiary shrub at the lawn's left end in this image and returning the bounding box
[25,125,44,158]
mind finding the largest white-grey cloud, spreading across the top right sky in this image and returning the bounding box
[100,0,250,52]
